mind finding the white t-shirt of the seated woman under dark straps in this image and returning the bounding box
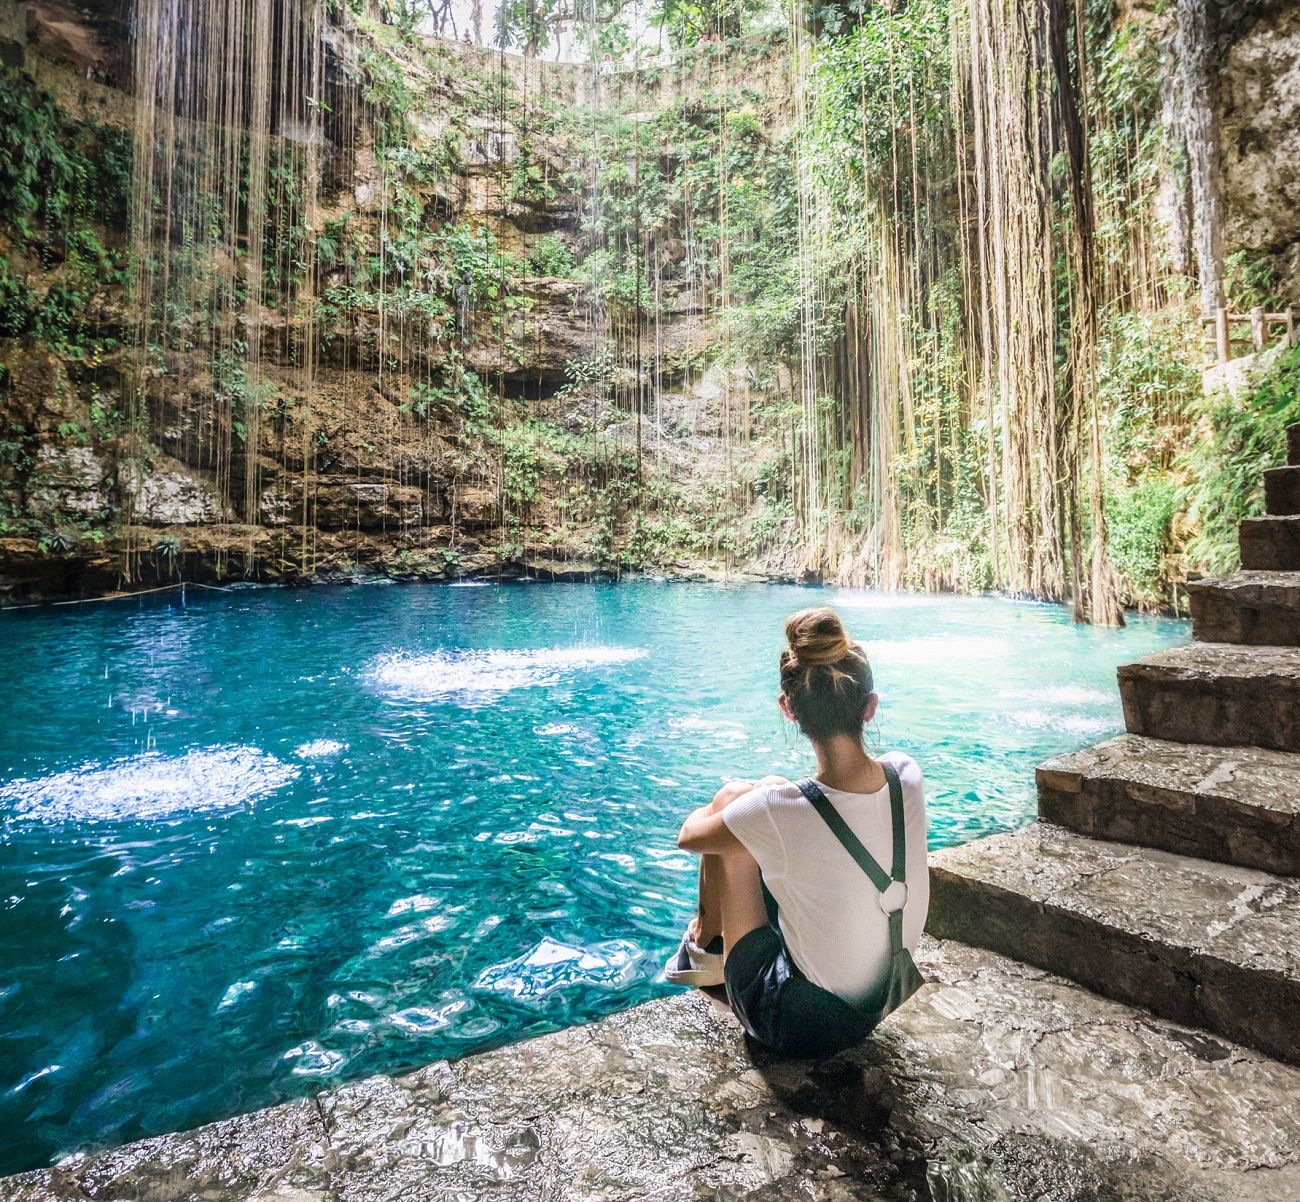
[723,751,930,1002]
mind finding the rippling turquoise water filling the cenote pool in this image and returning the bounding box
[0,582,1187,1172]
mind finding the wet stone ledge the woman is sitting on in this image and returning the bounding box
[0,940,1300,1202]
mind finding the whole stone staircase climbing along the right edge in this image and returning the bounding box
[928,425,1300,1064]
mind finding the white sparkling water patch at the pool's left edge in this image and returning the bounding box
[0,747,300,823]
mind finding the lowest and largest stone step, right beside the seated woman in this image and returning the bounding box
[927,823,1300,1064]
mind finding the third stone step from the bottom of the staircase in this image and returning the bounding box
[1118,643,1300,751]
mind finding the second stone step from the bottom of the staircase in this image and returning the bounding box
[1039,734,1300,876]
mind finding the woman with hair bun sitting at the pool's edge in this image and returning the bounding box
[666,608,930,1055]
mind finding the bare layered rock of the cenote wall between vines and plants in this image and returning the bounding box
[0,0,1300,602]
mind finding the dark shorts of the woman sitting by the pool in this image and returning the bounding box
[723,924,871,1056]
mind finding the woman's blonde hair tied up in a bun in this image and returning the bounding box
[780,606,872,738]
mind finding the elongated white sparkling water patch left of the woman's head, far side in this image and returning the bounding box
[367,646,646,702]
